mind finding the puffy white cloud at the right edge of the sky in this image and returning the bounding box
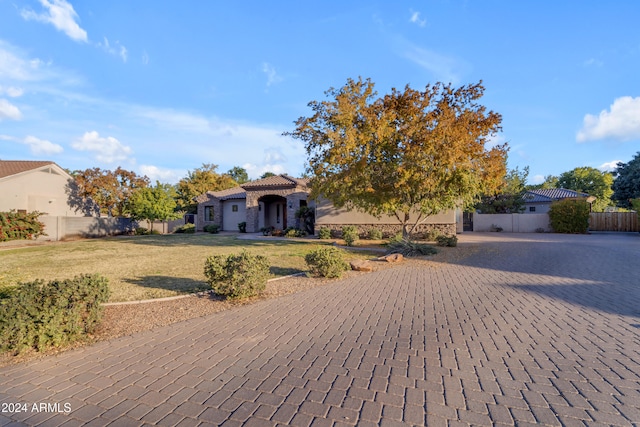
[576,96,640,142]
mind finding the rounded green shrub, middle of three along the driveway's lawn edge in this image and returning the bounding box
[204,250,269,298]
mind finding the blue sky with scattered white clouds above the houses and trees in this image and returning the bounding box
[0,0,640,183]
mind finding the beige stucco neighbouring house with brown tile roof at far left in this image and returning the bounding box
[0,160,84,216]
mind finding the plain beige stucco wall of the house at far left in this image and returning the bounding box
[0,166,84,217]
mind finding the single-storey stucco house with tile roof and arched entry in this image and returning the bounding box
[196,175,462,234]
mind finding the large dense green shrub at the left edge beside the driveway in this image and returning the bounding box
[0,275,109,353]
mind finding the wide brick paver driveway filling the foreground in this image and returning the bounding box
[0,233,640,426]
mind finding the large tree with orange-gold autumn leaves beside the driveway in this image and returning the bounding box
[285,79,507,238]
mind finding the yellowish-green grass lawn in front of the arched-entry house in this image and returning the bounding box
[0,234,380,302]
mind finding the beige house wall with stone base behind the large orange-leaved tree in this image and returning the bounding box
[316,200,457,238]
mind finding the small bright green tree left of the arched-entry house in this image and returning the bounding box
[128,181,182,232]
